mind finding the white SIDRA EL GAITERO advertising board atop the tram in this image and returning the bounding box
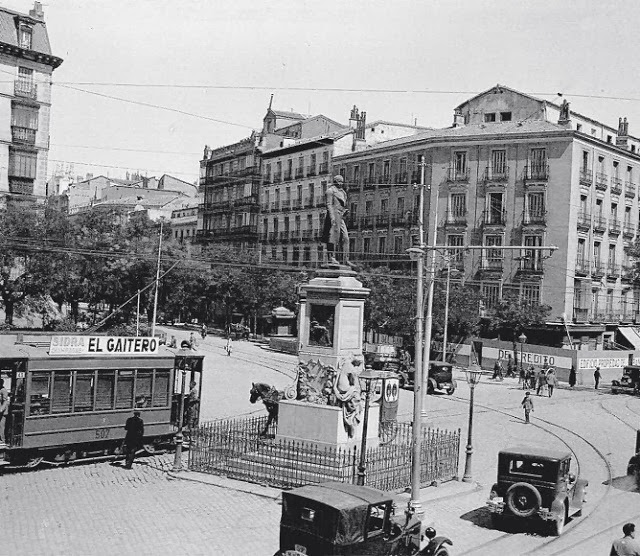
[49,336,160,356]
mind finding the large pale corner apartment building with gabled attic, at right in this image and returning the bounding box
[333,86,640,332]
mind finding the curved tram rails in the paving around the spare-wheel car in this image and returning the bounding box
[444,396,613,556]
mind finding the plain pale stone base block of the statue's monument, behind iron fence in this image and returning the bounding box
[276,400,380,449]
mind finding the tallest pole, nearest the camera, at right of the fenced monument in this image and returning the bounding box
[408,155,425,515]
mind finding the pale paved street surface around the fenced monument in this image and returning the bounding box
[0,332,640,556]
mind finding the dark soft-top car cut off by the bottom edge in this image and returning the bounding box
[275,482,453,556]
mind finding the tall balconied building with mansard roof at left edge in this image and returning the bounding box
[0,2,62,206]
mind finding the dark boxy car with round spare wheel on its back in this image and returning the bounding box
[487,447,589,535]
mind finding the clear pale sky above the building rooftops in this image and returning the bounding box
[5,0,640,182]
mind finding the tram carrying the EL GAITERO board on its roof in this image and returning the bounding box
[0,335,203,468]
